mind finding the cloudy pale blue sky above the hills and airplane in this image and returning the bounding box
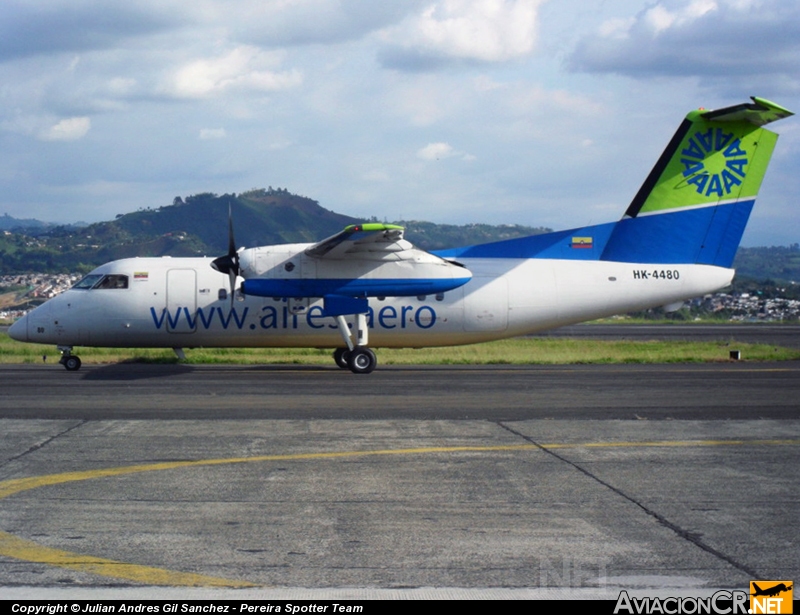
[0,0,800,246]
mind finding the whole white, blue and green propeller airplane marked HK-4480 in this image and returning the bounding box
[8,97,793,374]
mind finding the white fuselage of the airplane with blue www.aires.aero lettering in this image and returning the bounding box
[9,257,734,348]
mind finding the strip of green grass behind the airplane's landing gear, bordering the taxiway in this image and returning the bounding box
[0,334,800,365]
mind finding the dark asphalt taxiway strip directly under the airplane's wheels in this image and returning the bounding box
[0,362,800,421]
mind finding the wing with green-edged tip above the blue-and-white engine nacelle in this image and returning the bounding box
[305,222,413,259]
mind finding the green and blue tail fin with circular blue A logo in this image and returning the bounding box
[600,97,793,267]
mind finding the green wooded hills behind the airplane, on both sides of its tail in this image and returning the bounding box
[0,187,800,320]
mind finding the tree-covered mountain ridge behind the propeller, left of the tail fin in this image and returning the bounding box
[0,187,548,273]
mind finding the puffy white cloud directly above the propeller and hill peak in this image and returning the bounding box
[168,46,303,98]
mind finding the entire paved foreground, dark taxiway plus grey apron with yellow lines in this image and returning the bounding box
[0,330,800,598]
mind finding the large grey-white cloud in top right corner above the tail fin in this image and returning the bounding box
[569,0,800,93]
